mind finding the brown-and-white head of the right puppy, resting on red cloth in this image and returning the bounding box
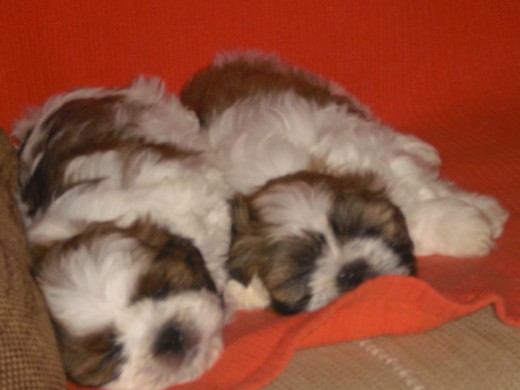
[227,172,415,314]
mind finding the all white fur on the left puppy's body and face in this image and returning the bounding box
[14,78,230,389]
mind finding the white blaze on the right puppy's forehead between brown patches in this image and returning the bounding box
[254,181,332,237]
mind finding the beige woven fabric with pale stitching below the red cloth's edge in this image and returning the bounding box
[265,308,520,390]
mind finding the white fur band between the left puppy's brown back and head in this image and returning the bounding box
[29,145,230,288]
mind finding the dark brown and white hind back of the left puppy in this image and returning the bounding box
[13,78,204,218]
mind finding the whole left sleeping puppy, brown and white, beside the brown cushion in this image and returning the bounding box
[14,78,230,389]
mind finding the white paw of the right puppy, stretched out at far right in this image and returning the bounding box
[407,199,496,257]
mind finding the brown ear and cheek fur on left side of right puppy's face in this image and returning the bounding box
[226,195,323,314]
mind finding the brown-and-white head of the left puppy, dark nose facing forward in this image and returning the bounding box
[34,222,226,389]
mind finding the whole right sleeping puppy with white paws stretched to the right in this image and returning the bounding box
[181,52,507,313]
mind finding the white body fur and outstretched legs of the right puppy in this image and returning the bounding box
[209,68,508,256]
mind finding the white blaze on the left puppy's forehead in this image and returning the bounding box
[38,233,146,336]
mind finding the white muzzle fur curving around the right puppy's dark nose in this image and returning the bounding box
[306,237,409,311]
